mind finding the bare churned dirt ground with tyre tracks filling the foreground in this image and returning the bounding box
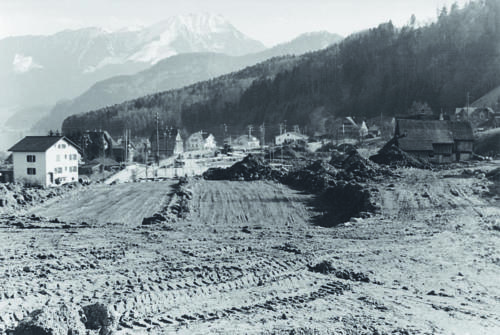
[0,169,500,334]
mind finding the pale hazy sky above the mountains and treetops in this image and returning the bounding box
[0,0,465,46]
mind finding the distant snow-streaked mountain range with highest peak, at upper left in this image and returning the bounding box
[0,13,265,107]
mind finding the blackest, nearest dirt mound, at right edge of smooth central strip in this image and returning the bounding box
[316,181,377,227]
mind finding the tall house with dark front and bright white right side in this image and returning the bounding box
[149,128,184,158]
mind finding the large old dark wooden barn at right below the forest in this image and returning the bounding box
[395,119,474,163]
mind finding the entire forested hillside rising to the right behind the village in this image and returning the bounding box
[63,0,500,139]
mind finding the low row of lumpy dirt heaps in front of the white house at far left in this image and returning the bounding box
[0,183,81,209]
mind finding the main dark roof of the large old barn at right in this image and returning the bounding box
[396,120,454,151]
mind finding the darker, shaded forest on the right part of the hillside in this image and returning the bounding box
[182,0,500,133]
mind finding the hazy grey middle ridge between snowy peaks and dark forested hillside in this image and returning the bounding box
[24,32,342,132]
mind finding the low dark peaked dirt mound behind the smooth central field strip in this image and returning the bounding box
[203,154,281,181]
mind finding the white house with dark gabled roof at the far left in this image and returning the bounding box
[9,136,80,186]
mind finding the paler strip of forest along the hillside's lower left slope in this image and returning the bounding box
[62,56,297,136]
